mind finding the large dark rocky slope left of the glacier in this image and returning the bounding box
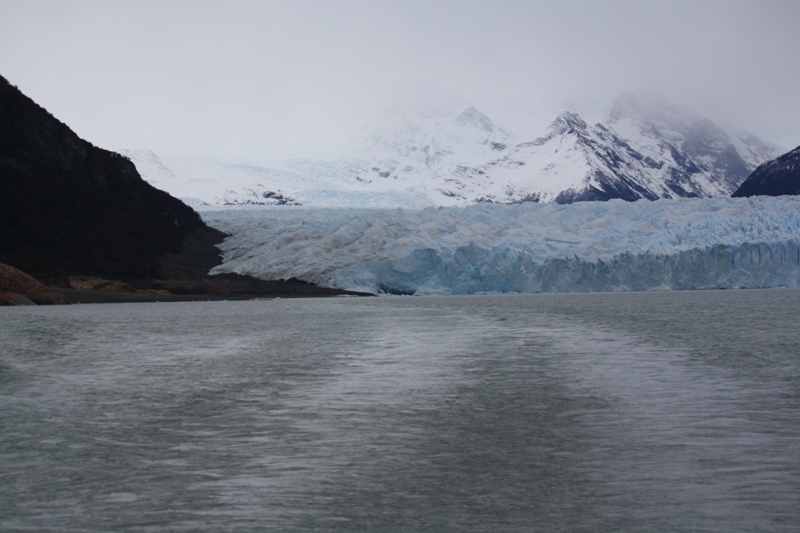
[0,77,224,280]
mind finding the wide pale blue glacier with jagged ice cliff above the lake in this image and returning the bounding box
[201,196,800,294]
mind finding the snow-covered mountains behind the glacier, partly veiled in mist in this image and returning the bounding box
[124,93,780,207]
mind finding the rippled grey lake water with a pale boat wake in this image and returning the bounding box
[0,289,800,532]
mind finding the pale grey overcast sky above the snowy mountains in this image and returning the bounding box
[0,0,800,161]
